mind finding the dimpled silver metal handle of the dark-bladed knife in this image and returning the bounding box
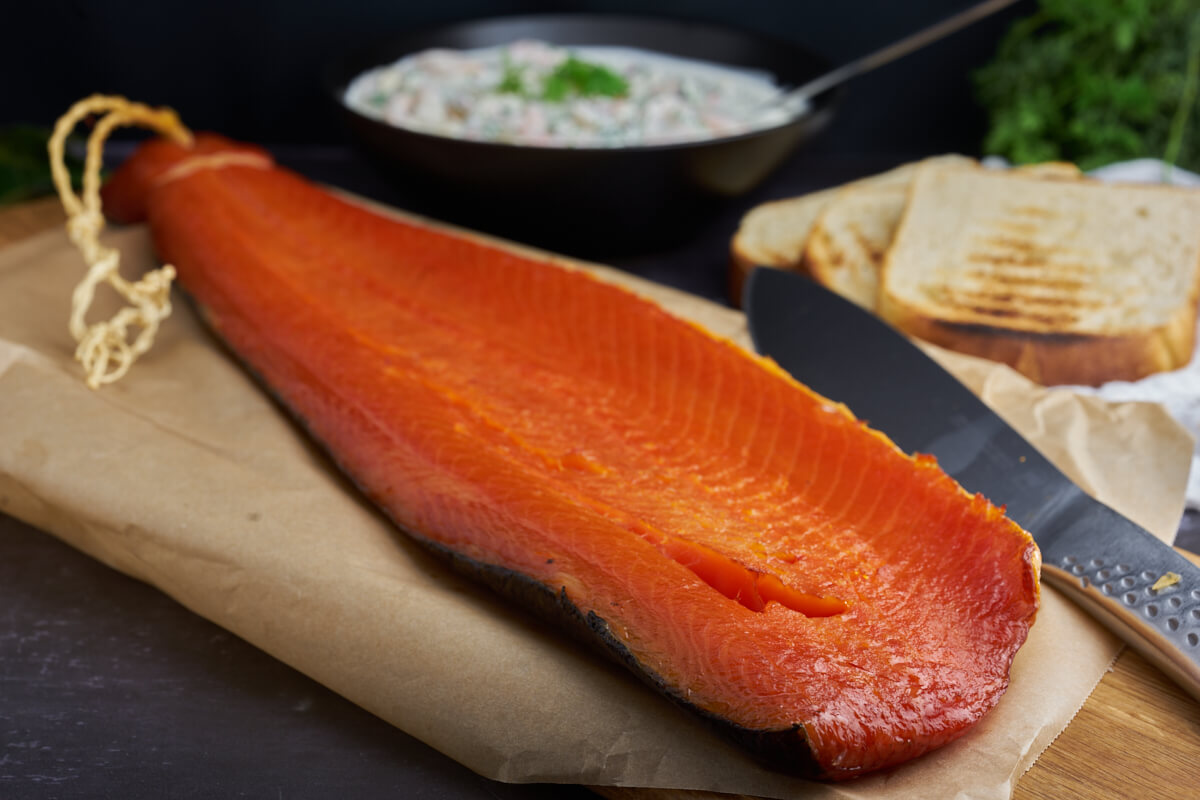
[1043,547,1200,702]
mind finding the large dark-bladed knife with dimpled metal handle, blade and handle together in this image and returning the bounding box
[743,267,1200,700]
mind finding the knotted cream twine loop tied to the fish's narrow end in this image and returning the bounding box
[49,95,192,389]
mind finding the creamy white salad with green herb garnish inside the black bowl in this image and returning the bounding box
[344,41,799,148]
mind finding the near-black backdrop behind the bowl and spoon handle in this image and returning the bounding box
[0,0,1033,156]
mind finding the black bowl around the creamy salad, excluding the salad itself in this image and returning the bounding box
[325,14,836,254]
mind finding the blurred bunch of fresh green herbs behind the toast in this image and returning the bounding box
[974,0,1200,170]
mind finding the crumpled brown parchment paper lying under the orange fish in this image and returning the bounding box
[0,219,1192,799]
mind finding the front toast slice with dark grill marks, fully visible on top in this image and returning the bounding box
[877,164,1200,385]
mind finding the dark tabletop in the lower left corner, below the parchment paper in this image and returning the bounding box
[0,515,595,800]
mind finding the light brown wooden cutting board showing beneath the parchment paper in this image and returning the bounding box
[0,198,1200,800]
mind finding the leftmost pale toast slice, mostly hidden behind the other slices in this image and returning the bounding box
[728,155,974,306]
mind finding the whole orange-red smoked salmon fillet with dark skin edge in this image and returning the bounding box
[104,136,1039,780]
